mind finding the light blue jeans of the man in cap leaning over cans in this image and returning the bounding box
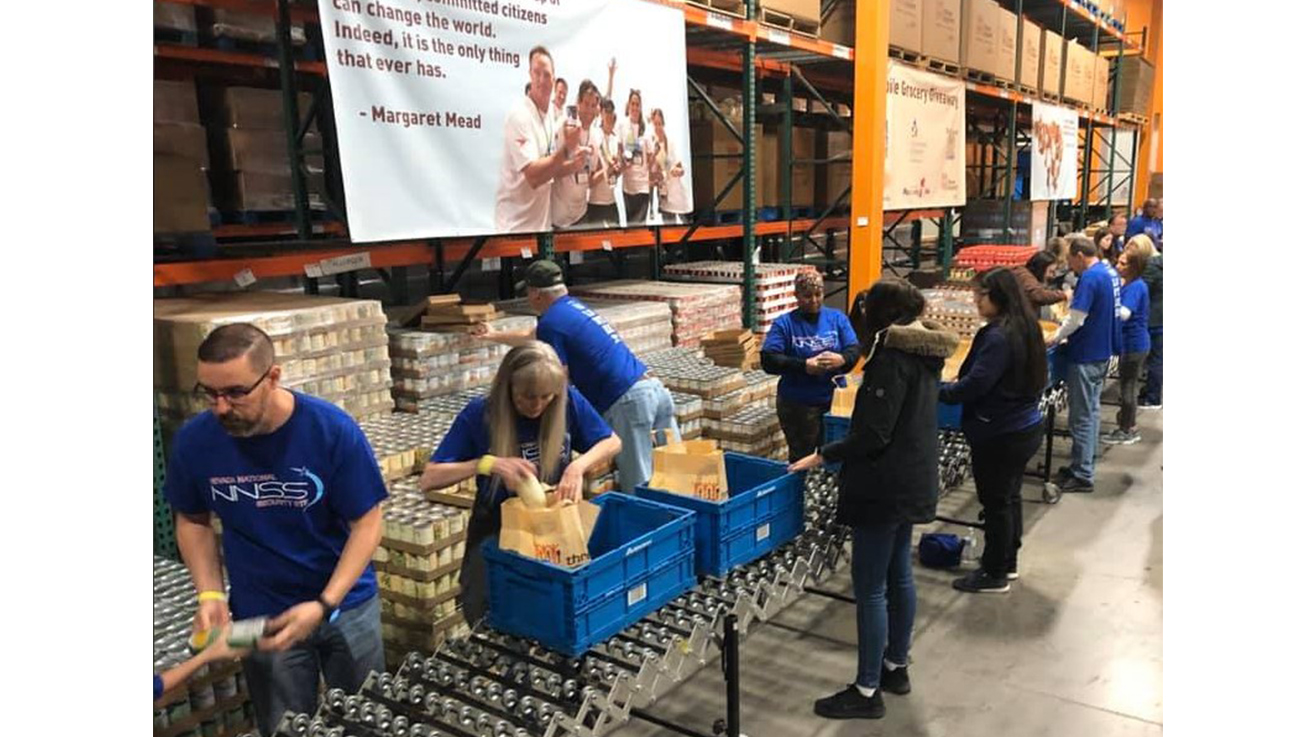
[603,379,680,494]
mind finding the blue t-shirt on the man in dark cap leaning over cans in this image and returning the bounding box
[534,296,645,413]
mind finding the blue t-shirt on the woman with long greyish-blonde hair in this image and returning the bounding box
[430,387,612,509]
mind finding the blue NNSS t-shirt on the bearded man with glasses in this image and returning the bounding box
[165,392,388,619]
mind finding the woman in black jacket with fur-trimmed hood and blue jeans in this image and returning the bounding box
[791,279,959,719]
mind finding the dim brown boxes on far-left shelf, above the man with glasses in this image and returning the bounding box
[153,79,211,233]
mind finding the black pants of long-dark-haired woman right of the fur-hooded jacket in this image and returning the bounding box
[969,422,1042,578]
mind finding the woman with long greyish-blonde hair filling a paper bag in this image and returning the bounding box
[420,341,621,624]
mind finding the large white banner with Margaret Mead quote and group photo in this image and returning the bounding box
[320,0,692,242]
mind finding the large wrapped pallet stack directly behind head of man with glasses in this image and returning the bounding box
[155,292,393,439]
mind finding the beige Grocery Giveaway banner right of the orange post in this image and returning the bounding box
[882,62,965,209]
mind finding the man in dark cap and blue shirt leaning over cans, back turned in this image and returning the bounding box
[475,261,680,494]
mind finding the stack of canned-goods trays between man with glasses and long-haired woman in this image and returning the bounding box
[374,476,470,653]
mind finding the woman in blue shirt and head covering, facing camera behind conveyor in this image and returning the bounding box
[759,271,859,463]
